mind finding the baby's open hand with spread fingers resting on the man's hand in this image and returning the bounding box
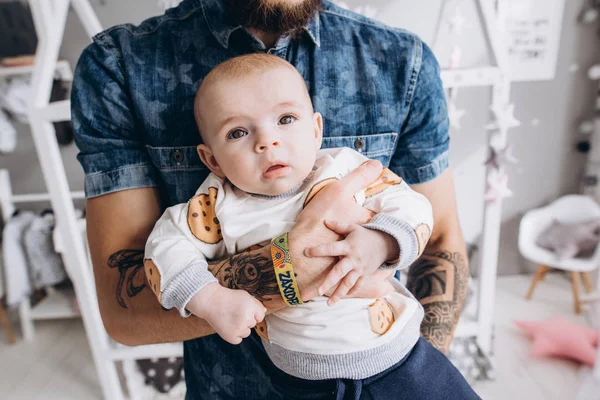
[305,221,399,306]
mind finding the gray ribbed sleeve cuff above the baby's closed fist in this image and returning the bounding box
[161,261,218,317]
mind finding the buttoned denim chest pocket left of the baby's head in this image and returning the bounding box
[146,146,210,205]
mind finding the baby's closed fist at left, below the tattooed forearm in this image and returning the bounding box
[186,283,267,344]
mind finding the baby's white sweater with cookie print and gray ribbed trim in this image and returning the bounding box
[145,148,433,379]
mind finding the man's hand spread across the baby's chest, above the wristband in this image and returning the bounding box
[288,160,383,301]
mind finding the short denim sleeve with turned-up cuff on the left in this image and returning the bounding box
[71,34,159,198]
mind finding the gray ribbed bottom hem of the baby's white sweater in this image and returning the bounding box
[262,279,424,380]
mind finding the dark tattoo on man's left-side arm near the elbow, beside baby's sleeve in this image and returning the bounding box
[108,249,146,308]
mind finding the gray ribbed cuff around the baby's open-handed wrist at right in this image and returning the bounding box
[363,214,419,269]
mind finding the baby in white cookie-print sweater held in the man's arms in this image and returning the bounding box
[145,54,433,380]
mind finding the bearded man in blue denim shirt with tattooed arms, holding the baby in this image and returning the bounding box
[72,0,468,399]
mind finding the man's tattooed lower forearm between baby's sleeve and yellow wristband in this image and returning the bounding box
[208,248,280,303]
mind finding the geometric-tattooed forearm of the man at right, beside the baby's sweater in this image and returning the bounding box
[408,251,468,352]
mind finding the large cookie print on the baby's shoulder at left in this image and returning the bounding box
[187,187,223,244]
